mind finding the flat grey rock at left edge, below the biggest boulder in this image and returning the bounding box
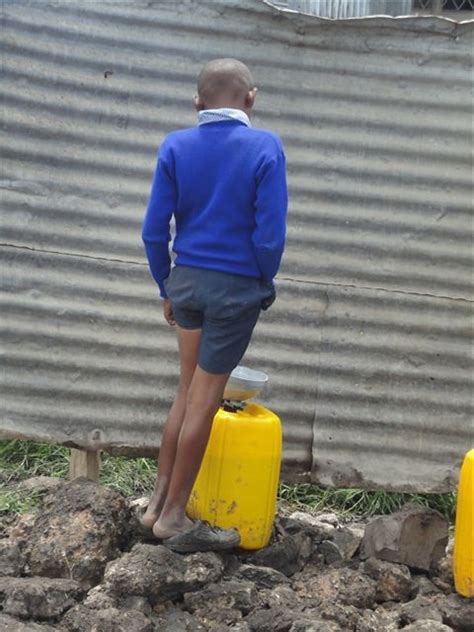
[0,577,82,620]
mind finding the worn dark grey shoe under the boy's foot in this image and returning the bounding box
[162,520,240,553]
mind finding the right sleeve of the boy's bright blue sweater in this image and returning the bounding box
[252,145,288,284]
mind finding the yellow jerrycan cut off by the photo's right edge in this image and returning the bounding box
[453,450,474,597]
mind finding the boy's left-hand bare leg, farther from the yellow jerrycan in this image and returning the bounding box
[142,326,201,527]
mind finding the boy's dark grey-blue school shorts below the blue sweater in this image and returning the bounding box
[165,266,273,374]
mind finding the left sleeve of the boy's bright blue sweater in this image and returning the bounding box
[142,141,177,298]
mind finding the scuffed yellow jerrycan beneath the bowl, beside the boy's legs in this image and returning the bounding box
[186,403,282,549]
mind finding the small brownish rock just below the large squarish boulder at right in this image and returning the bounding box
[363,557,413,603]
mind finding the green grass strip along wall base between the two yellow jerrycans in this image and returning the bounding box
[279,483,456,522]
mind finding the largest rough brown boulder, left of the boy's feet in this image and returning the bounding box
[11,479,128,588]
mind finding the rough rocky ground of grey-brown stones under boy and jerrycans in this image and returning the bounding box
[0,479,474,632]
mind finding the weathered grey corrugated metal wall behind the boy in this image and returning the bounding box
[1,0,473,491]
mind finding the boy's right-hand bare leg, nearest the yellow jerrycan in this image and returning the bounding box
[153,367,229,538]
